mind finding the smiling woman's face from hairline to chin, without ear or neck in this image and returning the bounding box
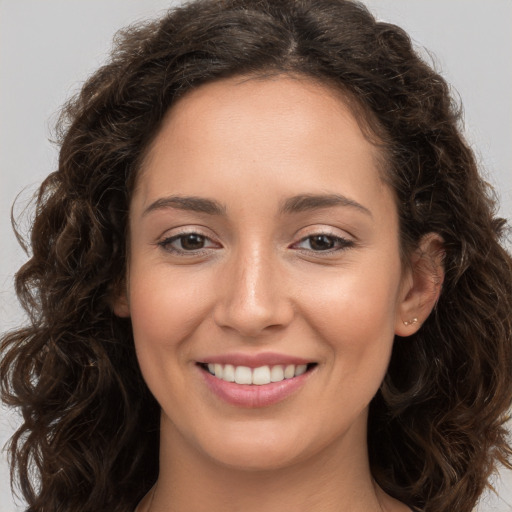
[115,77,416,469]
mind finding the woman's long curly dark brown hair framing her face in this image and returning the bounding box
[0,0,512,512]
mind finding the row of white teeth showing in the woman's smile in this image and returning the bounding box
[208,363,307,386]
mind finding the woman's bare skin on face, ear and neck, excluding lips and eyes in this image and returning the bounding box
[115,76,439,512]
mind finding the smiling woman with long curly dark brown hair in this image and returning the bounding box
[1,0,512,512]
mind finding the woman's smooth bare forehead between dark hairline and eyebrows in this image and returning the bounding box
[134,75,394,218]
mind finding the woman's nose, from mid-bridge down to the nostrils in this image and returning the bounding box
[214,247,294,338]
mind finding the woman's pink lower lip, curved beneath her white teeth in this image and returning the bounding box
[200,368,314,408]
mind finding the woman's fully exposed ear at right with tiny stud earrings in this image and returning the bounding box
[395,233,445,336]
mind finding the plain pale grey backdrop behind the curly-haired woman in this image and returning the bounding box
[0,0,512,512]
